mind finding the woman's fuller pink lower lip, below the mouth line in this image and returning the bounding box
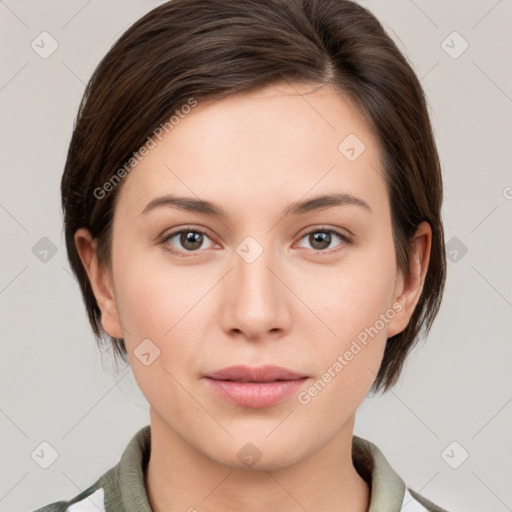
[208,379,306,408]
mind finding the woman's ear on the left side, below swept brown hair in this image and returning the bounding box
[75,228,123,338]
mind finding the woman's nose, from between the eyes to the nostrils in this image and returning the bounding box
[221,242,296,341]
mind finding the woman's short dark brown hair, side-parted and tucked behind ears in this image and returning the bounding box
[61,0,446,391]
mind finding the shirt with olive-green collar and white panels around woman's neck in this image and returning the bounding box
[35,425,447,512]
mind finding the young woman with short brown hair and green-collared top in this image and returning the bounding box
[35,0,446,512]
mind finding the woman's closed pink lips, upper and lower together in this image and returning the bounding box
[205,365,308,408]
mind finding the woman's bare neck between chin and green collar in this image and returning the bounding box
[145,409,370,512]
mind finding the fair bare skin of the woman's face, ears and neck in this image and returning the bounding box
[75,84,431,512]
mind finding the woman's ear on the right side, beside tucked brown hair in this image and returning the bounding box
[387,222,432,338]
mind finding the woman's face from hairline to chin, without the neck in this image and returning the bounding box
[83,85,420,468]
